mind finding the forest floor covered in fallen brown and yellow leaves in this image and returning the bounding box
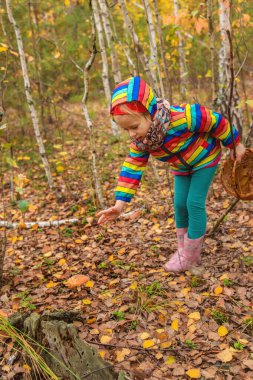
[0,105,253,380]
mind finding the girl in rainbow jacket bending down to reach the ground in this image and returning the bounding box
[98,76,245,272]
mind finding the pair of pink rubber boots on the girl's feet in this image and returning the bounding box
[164,233,204,272]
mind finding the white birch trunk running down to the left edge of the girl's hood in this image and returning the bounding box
[91,0,119,135]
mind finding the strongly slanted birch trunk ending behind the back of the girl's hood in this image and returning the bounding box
[118,0,159,93]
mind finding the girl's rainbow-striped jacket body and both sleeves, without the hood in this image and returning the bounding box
[115,104,240,202]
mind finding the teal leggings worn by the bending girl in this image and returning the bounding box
[174,165,217,239]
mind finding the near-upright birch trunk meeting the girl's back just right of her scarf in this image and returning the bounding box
[143,0,165,98]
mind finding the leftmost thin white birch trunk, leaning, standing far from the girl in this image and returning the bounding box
[6,0,54,189]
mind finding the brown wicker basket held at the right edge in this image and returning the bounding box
[221,149,253,200]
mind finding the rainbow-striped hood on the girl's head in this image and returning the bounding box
[111,76,157,116]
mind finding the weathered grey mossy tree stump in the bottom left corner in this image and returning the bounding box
[10,312,124,380]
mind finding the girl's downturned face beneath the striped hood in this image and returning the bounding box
[114,114,152,141]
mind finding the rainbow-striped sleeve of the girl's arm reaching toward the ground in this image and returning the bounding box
[115,143,149,202]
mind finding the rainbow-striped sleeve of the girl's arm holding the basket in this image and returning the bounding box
[185,103,240,149]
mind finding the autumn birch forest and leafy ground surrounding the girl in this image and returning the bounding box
[0,0,253,380]
